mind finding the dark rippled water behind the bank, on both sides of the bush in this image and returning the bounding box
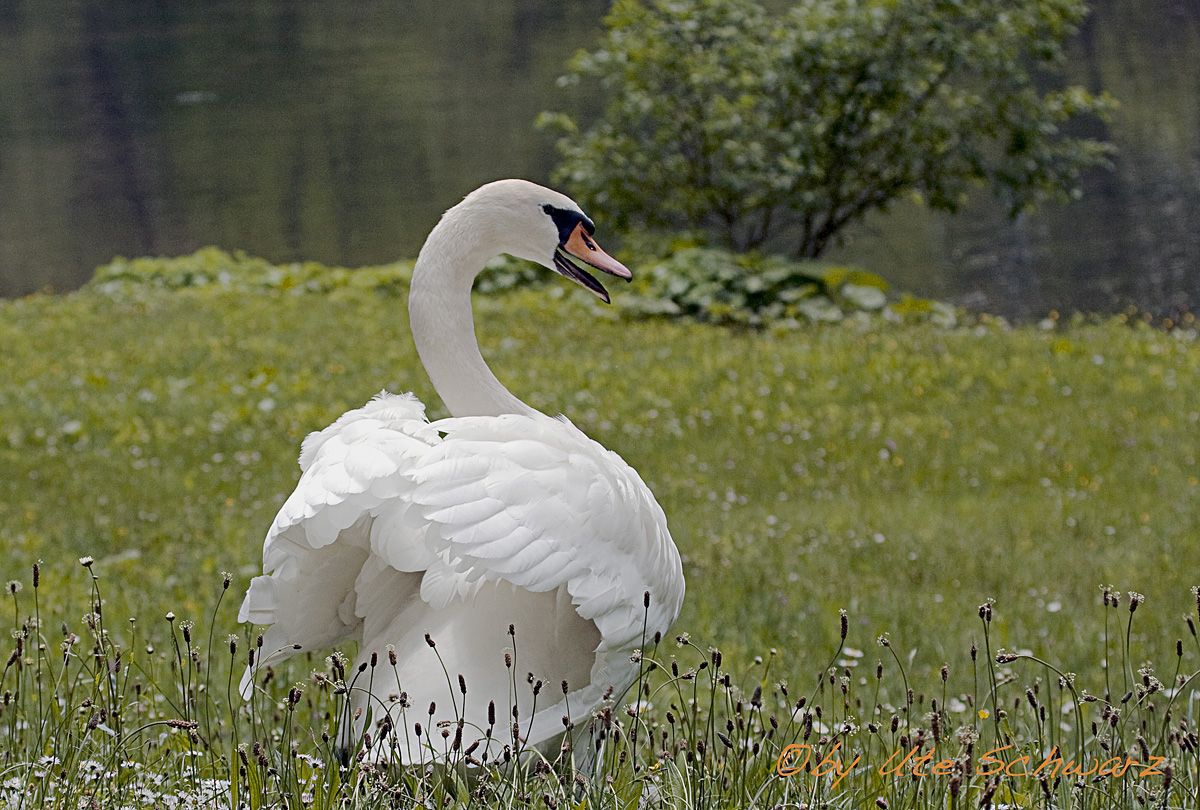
[0,0,1200,317]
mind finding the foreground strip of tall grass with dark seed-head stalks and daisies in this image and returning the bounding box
[0,558,1200,810]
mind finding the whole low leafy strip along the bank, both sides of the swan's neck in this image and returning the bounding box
[89,250,955,329]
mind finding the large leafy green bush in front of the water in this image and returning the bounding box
[541,0,1114,258]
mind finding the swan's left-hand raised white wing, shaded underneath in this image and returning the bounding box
[238,392,439,695]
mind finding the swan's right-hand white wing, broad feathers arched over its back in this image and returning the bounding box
[407,414,684,744]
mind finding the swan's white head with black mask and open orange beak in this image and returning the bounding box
[451,180,634,304]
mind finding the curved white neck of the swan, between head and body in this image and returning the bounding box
[408,212,539,416]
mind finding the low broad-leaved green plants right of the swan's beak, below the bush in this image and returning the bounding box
[616,247,956,329]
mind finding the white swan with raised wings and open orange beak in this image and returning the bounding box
[239,180,684,763]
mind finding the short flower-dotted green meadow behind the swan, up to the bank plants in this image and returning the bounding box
[0,266,1200,806]
